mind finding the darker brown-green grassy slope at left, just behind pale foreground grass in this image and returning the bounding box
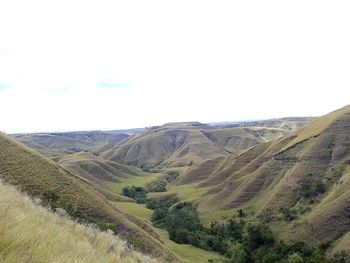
[0,134,177,261]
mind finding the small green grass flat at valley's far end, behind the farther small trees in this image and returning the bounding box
[105,174,163,194]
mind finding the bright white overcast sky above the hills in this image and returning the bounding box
[0,0,350,133]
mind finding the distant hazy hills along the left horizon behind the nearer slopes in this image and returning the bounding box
[13,131,129,157]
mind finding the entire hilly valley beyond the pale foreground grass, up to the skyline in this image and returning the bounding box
[0,112,350,263]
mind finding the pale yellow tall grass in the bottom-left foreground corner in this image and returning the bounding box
[0,182,156,263]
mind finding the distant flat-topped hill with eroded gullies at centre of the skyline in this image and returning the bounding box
[101,123,287,167]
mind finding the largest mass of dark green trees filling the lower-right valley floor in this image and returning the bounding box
[146,196,350,263]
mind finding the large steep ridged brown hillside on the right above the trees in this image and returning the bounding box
[176,106,350,248]
